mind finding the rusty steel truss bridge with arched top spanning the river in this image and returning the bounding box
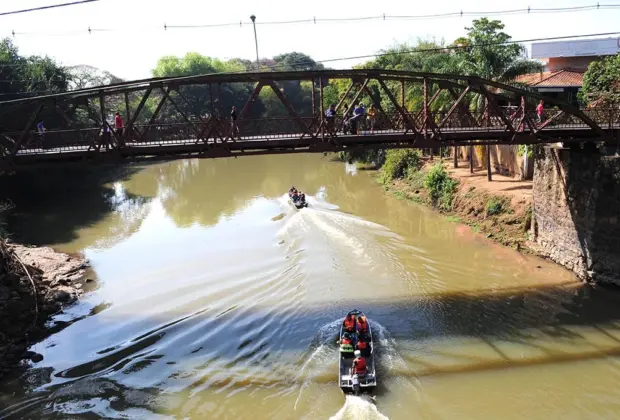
[0,69,620,169]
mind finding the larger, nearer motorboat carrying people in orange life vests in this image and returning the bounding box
[338,309,377,395]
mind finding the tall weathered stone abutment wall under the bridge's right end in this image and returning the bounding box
[532,147,620,285]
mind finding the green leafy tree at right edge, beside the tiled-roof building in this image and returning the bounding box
[579,55,620,104]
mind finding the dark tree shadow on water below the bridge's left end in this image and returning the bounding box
[0,164,154,246]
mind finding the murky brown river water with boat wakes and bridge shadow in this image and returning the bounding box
[0,155,620,419]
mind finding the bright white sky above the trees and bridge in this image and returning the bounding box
[0,0,620,79]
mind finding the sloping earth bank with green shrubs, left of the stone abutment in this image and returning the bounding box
[344,149,532,250]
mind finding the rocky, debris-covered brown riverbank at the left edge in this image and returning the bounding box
[0,240,90,378]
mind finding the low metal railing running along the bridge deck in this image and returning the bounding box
[0,108,620,155]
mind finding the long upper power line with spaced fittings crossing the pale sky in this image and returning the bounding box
[0,0,620,36]
